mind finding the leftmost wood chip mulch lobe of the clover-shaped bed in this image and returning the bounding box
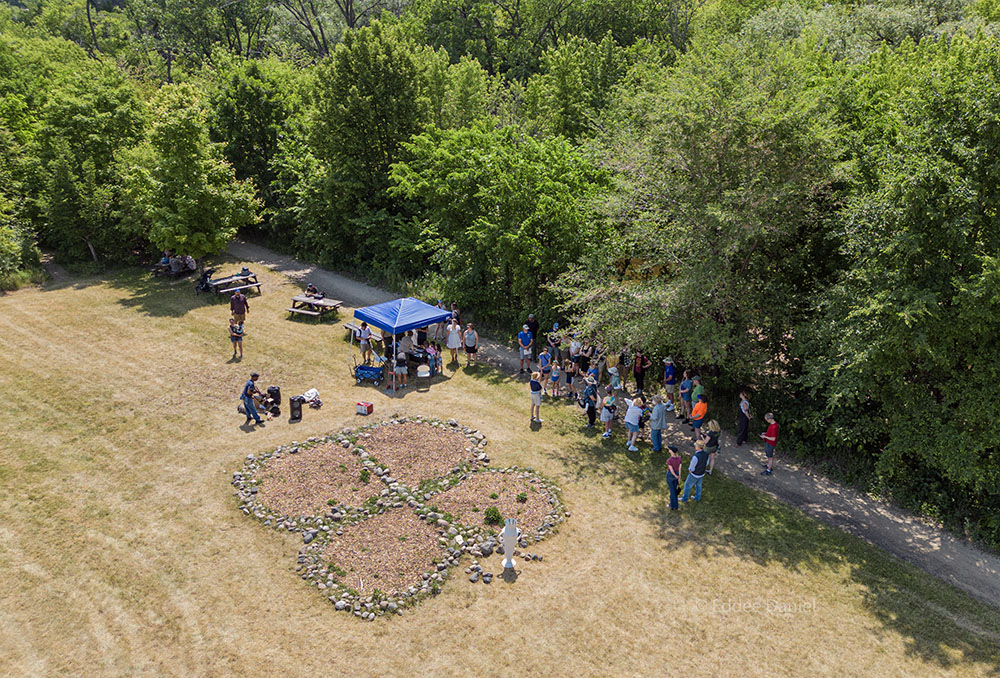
[257,443,383,516]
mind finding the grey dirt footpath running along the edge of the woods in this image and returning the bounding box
[229,242,1000,608]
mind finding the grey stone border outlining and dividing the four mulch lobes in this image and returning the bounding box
[232,416,570,621]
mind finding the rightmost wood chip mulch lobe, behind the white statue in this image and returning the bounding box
[428,471,552,533]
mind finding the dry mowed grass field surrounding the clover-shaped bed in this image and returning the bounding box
[0,262,1000,678]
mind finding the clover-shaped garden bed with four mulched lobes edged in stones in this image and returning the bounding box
[233,417,569,620]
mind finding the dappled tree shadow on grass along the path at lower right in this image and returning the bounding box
[555,435,1000,676]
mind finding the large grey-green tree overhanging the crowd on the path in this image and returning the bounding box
[567,39,838,384]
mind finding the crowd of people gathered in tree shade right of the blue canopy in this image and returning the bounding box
[517,315,778,509]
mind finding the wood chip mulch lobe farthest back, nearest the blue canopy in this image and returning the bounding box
[357,422,476,487]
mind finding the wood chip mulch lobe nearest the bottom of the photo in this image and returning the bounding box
[322,509,443,596]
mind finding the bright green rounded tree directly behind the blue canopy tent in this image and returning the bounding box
[392,121,604,322]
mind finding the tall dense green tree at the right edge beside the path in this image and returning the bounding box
[806,36,1000,540]
